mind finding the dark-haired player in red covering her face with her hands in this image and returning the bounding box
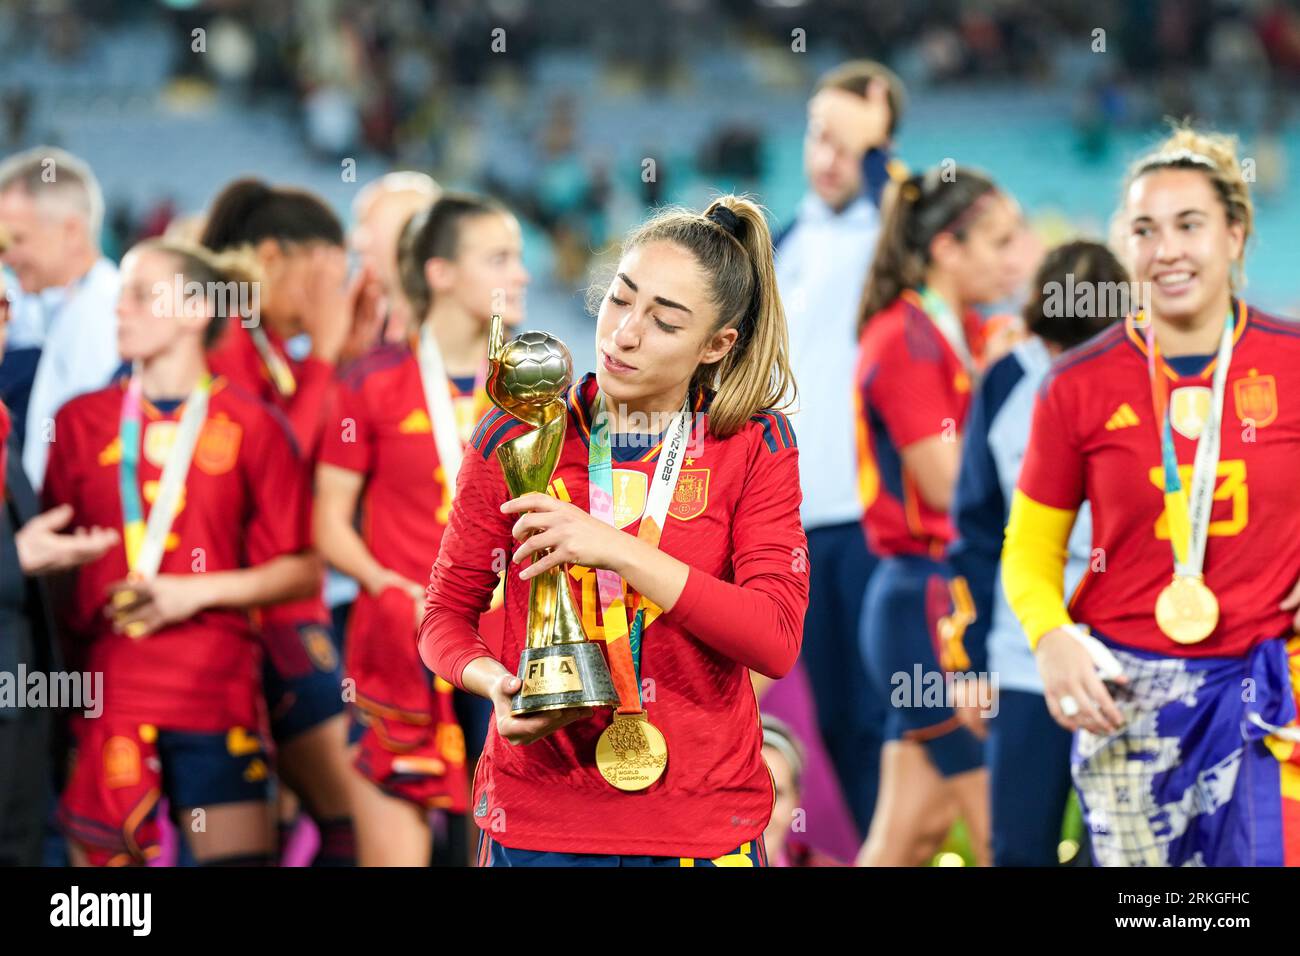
[200,179,378,865]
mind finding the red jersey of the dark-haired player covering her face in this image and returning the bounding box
[208,321,334,626]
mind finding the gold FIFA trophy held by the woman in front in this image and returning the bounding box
[488,316,619,715]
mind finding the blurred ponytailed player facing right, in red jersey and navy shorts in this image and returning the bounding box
[857,166,1022,866]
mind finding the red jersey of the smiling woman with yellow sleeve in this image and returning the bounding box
[1018,303,1300,657]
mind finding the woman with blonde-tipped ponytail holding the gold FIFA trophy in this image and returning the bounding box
[420,196,807,866]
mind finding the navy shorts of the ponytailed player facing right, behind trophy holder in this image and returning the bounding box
[861,555,984,777]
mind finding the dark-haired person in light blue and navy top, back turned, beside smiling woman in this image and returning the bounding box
[948,241,1128,866]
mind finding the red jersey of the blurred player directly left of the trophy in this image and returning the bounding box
[320,343,490,721]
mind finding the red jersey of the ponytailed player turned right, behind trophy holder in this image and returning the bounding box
[854,290,980,558]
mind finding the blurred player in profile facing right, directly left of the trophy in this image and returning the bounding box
[316,194,529,866]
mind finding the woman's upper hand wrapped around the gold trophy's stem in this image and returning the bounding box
[501,492,629,581]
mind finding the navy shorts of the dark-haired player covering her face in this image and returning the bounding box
[261,622,343,743]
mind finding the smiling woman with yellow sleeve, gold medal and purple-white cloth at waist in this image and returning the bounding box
[1002,129,1300,866]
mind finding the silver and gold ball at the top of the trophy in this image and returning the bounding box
[488,316,573,427]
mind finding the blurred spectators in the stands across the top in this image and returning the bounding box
[0,0,1300,300]
